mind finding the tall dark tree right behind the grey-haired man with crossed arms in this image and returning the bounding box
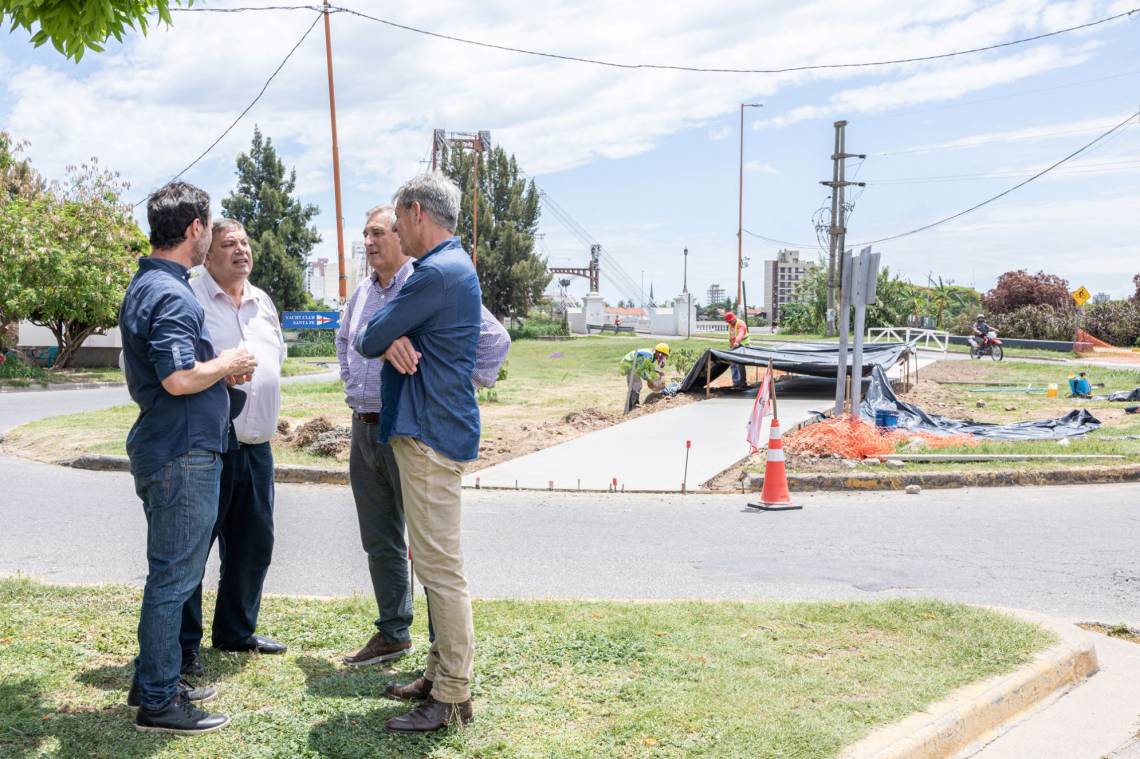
[442,147,552,319]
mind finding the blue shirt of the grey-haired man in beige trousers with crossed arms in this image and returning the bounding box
[356,237,482,462]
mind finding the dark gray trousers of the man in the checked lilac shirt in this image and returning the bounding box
[349,416,412,642]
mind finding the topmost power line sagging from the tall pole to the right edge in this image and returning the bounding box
[329,6,1140,74]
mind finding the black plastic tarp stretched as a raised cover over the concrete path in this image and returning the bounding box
[681,343,911,393]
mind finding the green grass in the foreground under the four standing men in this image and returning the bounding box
[0,576,1052,759]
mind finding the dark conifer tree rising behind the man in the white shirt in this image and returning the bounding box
[221,127,320,311]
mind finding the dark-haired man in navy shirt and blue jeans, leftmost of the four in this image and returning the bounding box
[119,182,257,735]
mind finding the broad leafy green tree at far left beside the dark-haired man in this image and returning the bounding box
[0,160,148,369]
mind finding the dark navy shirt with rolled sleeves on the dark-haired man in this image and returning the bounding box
[119,258,230,476]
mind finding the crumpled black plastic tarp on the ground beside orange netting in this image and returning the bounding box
[860,367,1100,440]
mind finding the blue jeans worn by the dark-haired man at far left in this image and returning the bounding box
[135,450,221,711]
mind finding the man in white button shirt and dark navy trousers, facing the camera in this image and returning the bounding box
[179,219,286,675]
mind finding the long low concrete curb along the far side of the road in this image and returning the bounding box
[62,454,1140,495]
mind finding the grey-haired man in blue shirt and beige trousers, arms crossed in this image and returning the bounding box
[356,173,482,733]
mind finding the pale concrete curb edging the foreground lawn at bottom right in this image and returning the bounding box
[841,610,1100,759]
